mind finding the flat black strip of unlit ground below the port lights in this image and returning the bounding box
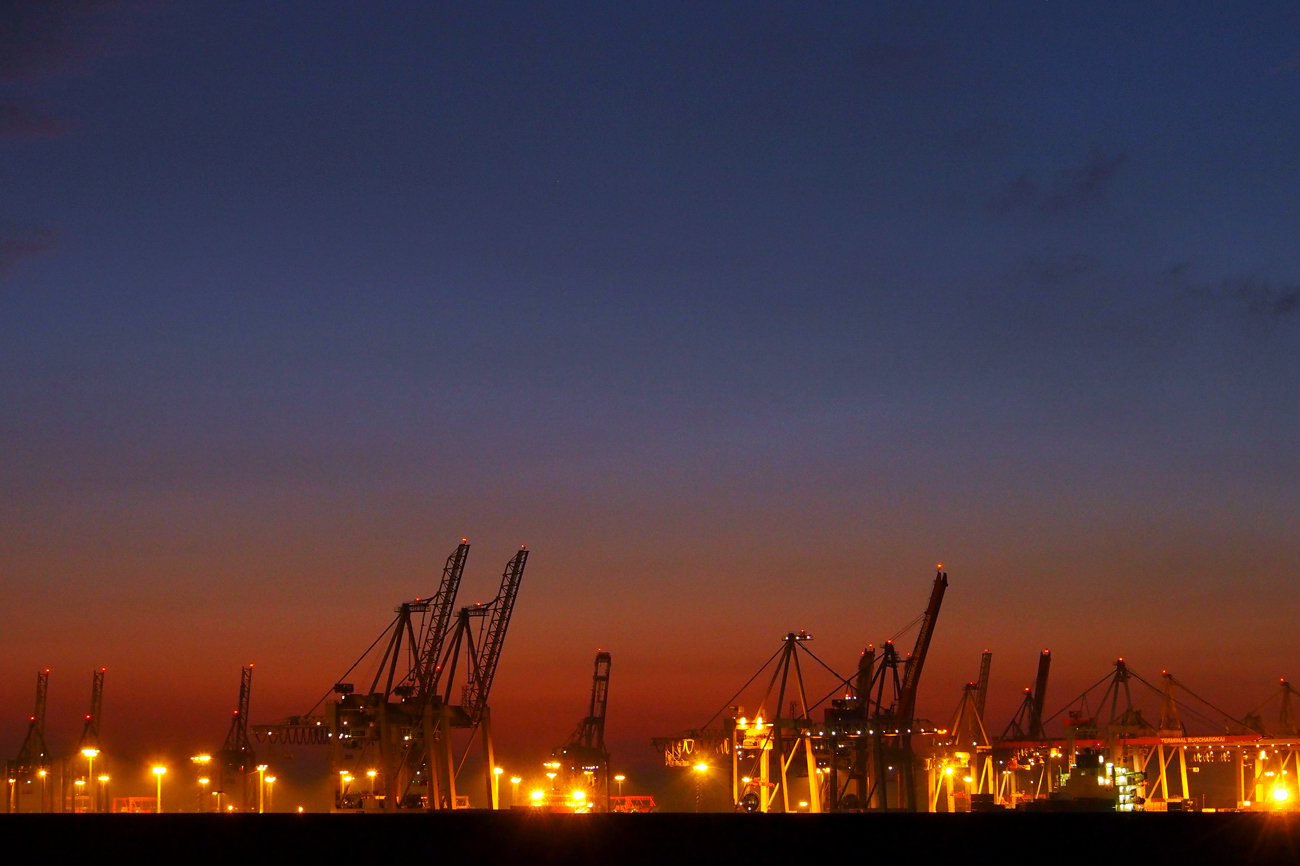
[0,811,1300,866]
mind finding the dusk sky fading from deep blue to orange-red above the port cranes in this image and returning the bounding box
[0,0,1300,785]
